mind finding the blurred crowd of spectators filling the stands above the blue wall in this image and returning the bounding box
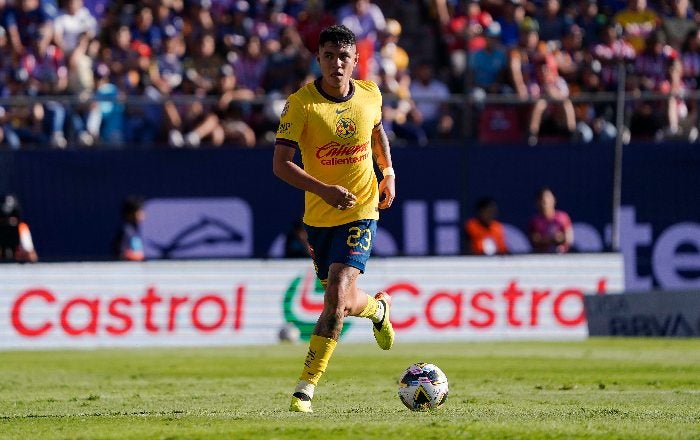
[0,0,700,149]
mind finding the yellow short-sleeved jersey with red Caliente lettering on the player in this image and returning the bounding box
[276,79,382,227]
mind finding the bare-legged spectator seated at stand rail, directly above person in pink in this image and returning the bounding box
[508,18,576,145]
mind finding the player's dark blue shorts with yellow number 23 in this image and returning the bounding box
[304,220,377,280]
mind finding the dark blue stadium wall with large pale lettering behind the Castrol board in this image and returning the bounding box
[0,143,700,291]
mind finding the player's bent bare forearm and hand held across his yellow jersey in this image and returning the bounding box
[272,143,357,209]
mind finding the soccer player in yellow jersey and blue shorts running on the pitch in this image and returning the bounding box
[273,25,396,412]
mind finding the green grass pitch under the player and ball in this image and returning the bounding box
[0,339,700,440]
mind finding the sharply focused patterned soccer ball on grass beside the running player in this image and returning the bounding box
[399,362,448,411]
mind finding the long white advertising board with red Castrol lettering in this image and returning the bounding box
[0,253,624,349]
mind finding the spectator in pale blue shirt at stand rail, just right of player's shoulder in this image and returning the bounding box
[409,62,454,140]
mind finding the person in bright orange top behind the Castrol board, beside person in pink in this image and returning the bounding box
[464,197,509,255]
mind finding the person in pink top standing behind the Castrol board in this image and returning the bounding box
[527,187,574,254]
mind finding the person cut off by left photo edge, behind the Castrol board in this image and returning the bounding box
[0,194,39,263]
